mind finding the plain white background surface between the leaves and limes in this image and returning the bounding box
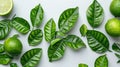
[0,0,120,67]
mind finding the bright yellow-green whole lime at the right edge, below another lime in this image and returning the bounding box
[105,18,120,37]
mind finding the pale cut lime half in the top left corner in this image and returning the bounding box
[0,0,13,15]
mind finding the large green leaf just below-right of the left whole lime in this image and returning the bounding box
[20,48,42,67]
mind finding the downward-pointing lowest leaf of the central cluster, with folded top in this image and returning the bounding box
[48,39,66,62]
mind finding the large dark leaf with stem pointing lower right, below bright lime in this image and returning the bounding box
[87,30,110,53]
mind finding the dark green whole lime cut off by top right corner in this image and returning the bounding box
[110,0,120,17]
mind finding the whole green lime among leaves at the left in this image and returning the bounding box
[4,35,22,56]
